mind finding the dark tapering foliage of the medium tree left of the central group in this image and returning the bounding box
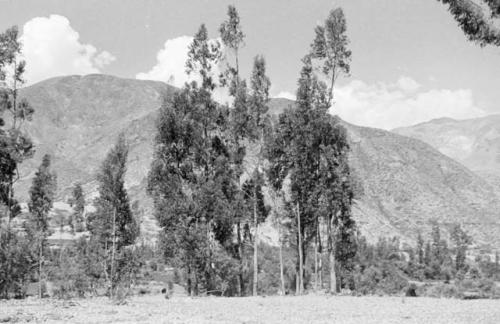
[87,134,139,298]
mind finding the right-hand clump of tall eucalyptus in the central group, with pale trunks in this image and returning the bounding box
[266,8,355,294]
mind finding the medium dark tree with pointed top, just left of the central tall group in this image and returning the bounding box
[87,134,139,298]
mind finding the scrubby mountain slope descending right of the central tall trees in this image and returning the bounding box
[346,125,500,245]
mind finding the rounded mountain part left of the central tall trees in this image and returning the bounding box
[15,75,175,238]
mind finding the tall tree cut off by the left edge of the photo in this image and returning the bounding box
[0,26,34,297]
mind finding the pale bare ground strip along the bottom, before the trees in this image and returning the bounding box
[0,295,500,324]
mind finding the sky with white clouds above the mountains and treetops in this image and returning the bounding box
[0,0,500,129]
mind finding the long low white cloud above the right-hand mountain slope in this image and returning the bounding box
[331,77,486,129]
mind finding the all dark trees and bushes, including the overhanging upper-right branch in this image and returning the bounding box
[0,0,500,300]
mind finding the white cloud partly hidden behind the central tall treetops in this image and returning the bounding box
[136,36,230,103]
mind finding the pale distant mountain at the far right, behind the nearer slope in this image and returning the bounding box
[394,115,500,189]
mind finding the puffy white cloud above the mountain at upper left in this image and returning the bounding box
[21,15,116,84]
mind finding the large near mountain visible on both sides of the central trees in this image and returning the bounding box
[16,75,500,247]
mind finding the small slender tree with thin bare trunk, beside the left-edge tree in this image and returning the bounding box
[28,154,56,298]
